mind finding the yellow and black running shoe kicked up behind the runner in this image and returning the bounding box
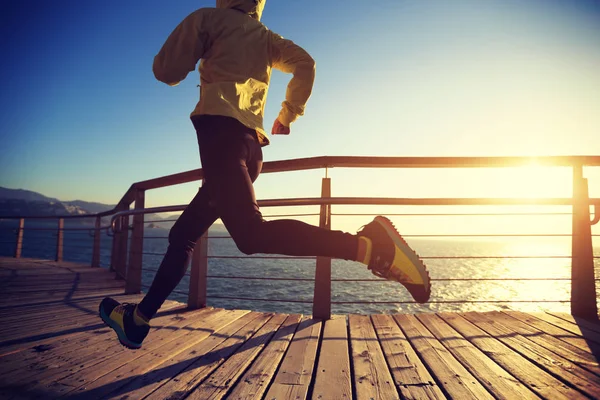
[358,216,431,303]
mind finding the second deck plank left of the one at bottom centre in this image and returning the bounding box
[186,314,287,400]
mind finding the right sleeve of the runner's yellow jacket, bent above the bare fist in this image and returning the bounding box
[272,34,315,126]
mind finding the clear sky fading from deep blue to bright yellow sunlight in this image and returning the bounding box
[0,0,600,228]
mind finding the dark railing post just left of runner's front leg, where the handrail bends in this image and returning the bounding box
[125,189,145,294]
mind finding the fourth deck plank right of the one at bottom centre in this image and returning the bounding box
[394,314,493,399]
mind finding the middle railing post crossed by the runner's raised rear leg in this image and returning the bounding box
[313,178,331,320]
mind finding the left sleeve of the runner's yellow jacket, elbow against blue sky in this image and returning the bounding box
[152,10,206,86]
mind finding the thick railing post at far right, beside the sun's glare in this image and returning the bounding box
[571,166,598,319]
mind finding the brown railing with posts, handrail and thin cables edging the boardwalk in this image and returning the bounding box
[1,156,600,319]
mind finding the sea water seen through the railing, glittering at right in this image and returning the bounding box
[0,223,600,314]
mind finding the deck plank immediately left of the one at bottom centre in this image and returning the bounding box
[228,314,301,400]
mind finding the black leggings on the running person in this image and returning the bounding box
[139,115,358,318]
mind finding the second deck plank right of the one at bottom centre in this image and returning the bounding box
[348,315,398,400]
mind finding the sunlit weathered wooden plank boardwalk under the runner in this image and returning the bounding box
[0,258,600,400]
